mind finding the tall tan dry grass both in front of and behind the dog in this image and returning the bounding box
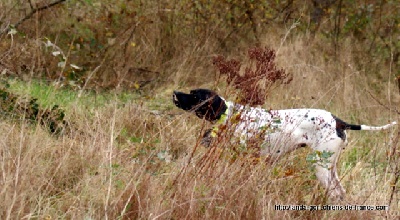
[0,34,400,219]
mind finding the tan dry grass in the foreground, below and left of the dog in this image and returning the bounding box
[0,49,399,219]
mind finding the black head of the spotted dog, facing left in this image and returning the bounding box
[172,89,227,121]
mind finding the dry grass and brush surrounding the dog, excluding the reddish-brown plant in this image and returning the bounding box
[0,0,400,219]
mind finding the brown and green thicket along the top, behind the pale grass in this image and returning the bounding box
[2,0,400,89]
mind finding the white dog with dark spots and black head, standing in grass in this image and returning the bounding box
[173,89,396,199]
